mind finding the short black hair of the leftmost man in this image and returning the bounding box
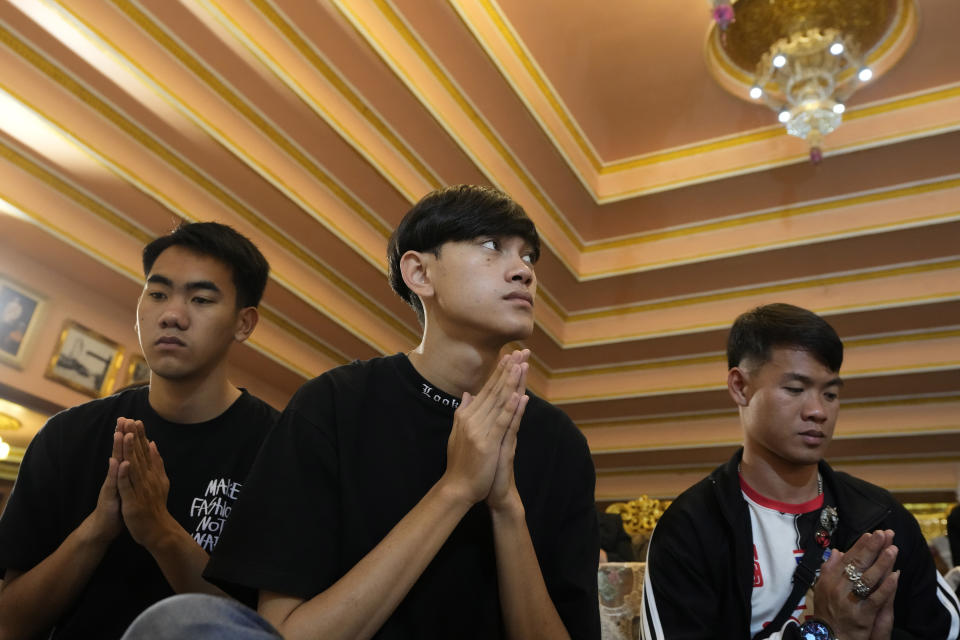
[143,222,270,309]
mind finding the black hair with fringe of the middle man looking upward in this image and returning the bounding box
[387,184,540,324]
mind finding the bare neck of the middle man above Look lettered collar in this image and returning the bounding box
[409,335,500,398]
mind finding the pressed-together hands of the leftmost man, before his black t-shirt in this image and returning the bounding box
[94,418,175,549]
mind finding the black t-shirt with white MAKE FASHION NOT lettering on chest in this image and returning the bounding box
[0,387,279,638]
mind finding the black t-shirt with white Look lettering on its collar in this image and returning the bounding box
[204,355,600,640]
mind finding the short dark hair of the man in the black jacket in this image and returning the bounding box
[727,302,843,372]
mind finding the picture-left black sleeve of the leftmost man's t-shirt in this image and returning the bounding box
[0,416,65,574]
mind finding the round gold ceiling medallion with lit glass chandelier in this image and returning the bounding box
[707,0,917,164]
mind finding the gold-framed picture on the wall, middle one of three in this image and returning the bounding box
[43,320,123,398]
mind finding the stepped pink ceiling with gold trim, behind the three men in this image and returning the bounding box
[0,0,960,500]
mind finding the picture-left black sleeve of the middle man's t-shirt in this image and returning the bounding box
[204,378,341,599]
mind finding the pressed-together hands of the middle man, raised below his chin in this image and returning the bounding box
[444,349,530,511]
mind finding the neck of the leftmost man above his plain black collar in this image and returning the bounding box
[149,373,240,424]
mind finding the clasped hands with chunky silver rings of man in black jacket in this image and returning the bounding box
[814,529,900,640]
